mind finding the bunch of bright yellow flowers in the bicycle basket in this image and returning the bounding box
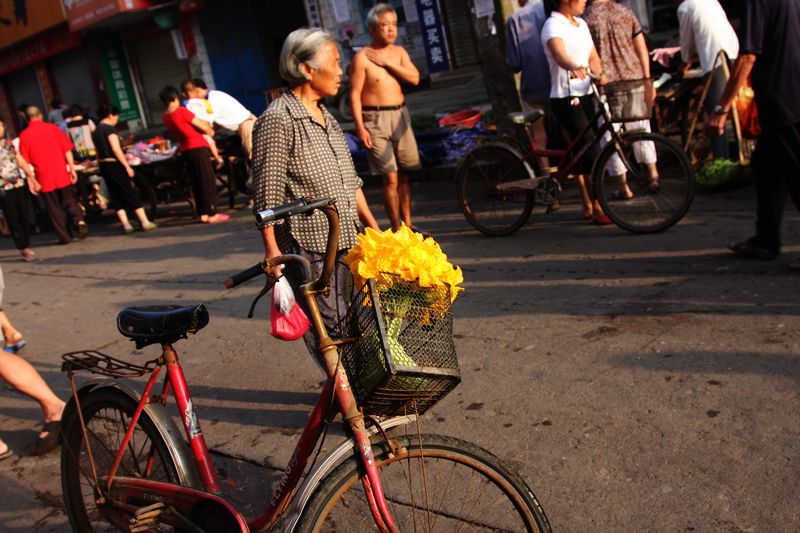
[344,224,464,302]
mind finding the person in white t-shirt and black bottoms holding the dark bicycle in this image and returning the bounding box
[542,0,612,225]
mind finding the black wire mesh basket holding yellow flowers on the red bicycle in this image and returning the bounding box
[336,275,461,416]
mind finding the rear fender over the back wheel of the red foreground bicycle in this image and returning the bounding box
[62,378,203,490]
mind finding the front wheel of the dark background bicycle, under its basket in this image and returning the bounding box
[594,132,694,233]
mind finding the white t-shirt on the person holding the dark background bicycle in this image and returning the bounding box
[542,11,594,98]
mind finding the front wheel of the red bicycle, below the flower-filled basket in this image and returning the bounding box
[299,435,550,533]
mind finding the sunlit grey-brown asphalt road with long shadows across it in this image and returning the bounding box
[0,177,800,532]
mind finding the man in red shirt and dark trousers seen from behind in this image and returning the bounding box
[19,106,89,244]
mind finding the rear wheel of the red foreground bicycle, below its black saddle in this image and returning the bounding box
[61,390,180,533]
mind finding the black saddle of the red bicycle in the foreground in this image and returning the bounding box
[117,304,208,348]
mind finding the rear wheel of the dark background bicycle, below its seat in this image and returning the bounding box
[456,143,534,237]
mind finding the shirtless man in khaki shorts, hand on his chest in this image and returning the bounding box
[350,4,420,231]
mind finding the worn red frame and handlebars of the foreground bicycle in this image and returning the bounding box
[70,204,404,532]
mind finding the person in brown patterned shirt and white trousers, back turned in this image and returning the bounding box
[586,0,659,200]
